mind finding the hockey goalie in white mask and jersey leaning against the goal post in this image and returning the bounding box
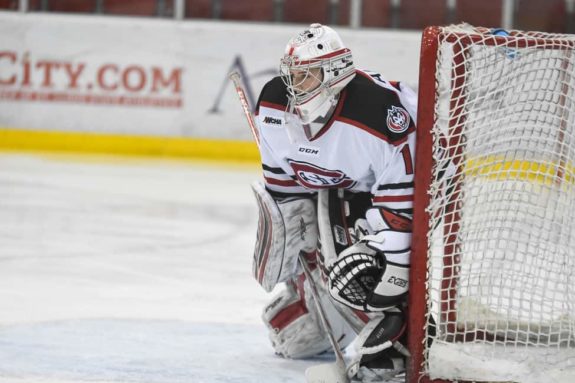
[252,24,417,382]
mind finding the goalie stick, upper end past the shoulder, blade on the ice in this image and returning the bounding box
[229,71,349,383]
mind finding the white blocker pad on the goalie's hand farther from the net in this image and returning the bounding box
[252,182,318,292]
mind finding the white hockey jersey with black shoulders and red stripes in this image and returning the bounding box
[256,70,417,214]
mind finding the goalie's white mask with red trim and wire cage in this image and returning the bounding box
[280,24,355,142]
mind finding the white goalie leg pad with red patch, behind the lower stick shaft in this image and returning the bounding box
[263,271,355,359]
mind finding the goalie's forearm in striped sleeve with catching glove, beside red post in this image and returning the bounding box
[330,140,415,311]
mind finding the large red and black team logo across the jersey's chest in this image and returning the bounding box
[288,160,355,189]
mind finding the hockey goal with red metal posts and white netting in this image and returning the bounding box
[407,24,575,383]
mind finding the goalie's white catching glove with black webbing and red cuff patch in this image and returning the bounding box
[329,208,411,312]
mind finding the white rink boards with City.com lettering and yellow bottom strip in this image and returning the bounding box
[0,12,420,161]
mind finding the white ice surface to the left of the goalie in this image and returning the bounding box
[0,153,326,383]
